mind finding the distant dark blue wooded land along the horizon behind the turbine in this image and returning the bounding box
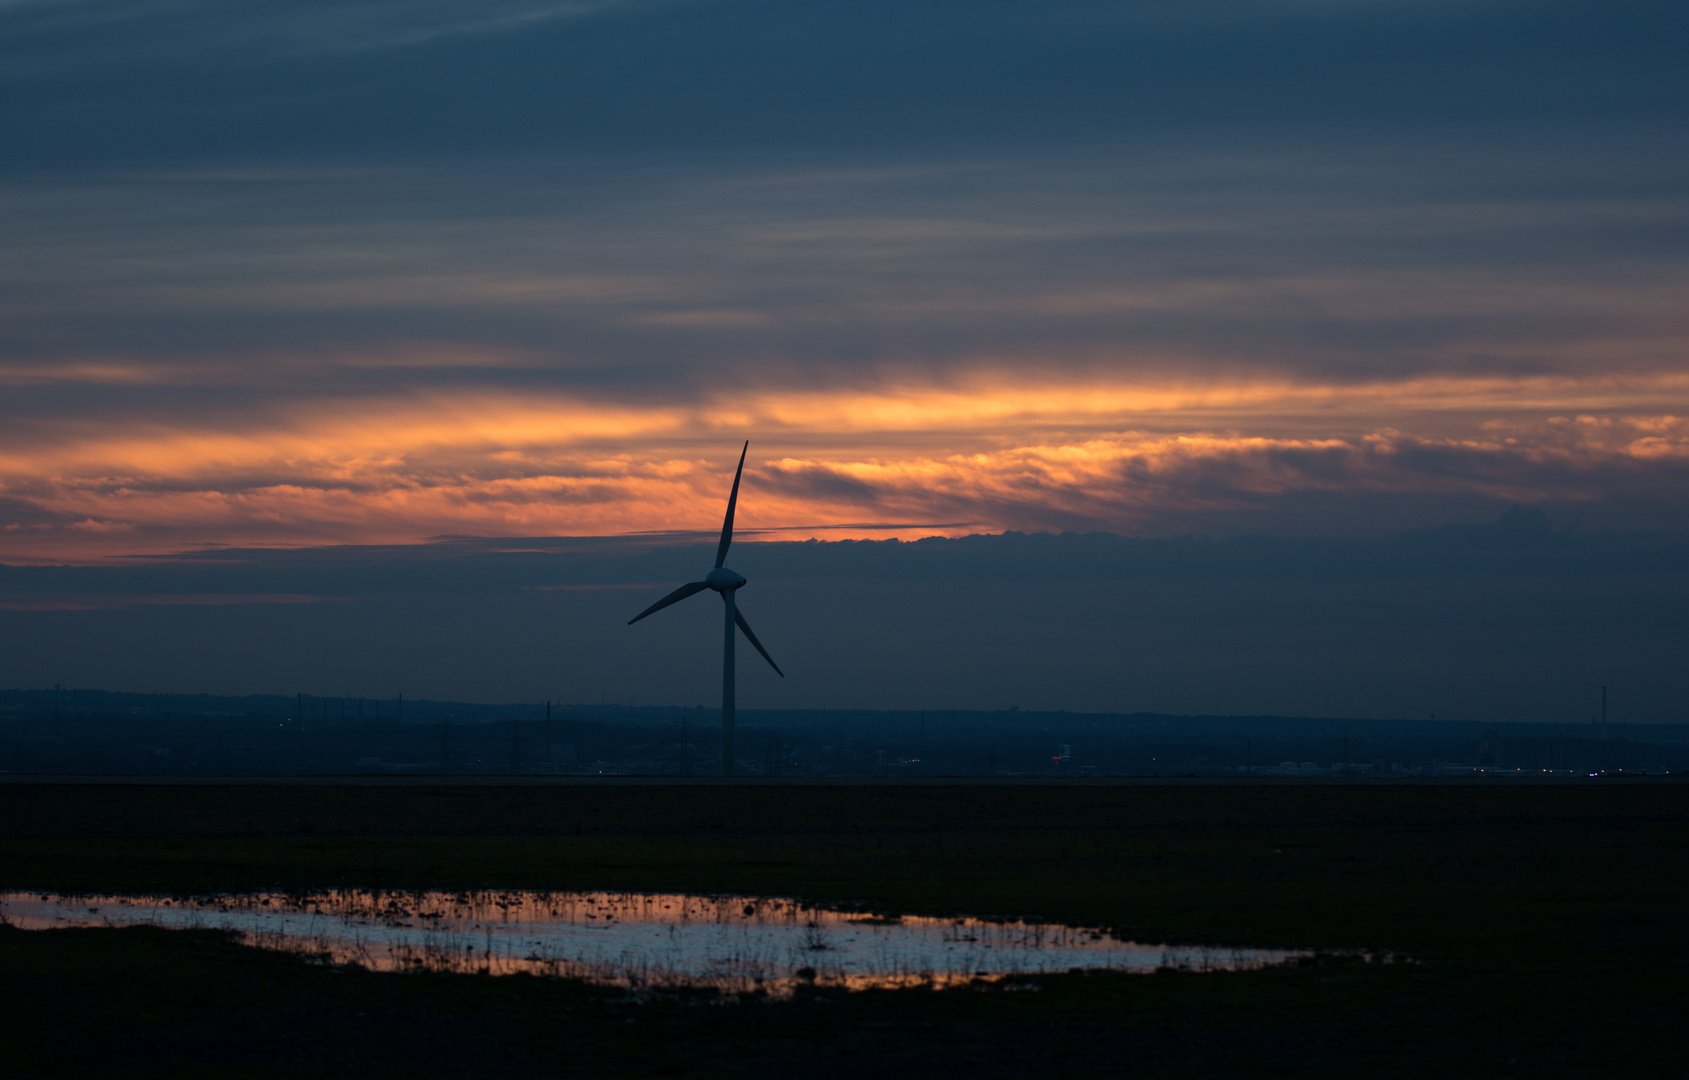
[0,688,1689,777]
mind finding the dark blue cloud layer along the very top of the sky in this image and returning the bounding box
[0,0,1684,155]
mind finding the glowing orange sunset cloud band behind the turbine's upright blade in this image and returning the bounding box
[0,375,1689,561]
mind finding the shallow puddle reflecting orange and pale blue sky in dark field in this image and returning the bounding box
[0,889,1311,997]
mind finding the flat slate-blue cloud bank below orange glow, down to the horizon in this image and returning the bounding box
[0,520,1689,722]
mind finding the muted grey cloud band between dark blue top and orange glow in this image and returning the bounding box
[0,145,1689,389]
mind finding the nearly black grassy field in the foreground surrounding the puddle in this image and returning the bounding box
[0,783,1689,1078]
